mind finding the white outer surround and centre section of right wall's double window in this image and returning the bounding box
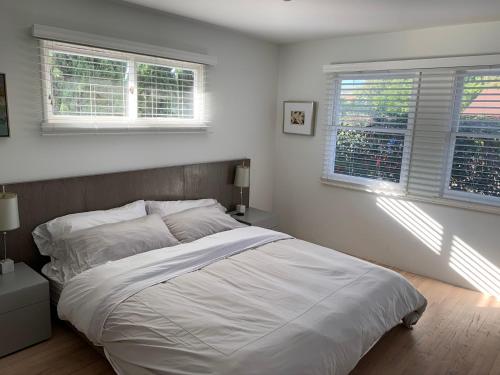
[320,58,500,214]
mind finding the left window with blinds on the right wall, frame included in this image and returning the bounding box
[326,74,418,189]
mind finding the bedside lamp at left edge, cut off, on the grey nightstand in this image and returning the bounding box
[0,186,19,274]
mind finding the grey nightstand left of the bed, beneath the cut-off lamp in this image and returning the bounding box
[0,263,51,357]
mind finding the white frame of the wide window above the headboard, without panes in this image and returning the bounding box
[40,40,208,133]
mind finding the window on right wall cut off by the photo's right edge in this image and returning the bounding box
[447,70,500,198]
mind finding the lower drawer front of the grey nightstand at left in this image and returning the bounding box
[0,299,51,357]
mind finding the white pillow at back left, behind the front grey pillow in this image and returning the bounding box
[33,200,147,256]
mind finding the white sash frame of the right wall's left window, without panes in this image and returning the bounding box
[327,73,420,195]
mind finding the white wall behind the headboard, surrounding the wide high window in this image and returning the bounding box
[0,0,278,212]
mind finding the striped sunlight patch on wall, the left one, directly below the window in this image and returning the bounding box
[377,197,443,255]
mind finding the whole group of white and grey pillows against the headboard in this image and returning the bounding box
[33,199,245,284]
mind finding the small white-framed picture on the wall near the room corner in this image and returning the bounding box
[283,101,316,136]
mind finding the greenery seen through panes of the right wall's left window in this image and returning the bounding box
[335,78,414,183]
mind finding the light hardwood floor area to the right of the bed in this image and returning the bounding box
[351,272,500,375]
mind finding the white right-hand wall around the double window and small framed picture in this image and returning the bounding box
[274,22,500,294]
